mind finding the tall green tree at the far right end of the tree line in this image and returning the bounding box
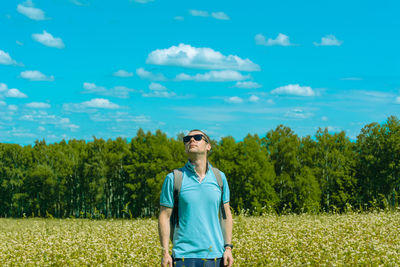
[357,116,400,207]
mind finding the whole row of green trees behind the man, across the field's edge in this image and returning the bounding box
[0,116,400,218]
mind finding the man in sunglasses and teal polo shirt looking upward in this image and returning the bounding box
[158,130,233,267]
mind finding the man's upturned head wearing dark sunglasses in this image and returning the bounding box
[183,129,211,156]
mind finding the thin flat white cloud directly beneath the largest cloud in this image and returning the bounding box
[176,70,250,82]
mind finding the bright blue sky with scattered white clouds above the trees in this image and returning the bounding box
[0,0,400,144]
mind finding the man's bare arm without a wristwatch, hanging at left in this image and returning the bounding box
[158,206,172,267]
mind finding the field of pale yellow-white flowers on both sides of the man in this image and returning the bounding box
[0,212,400,266]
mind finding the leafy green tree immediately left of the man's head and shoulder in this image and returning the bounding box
[125,129,185,217]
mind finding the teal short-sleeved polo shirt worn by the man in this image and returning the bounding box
[160,161,229,259]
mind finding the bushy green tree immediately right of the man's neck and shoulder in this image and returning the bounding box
[210,135,278,213]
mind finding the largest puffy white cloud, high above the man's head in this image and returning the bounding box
[146,43,260,71]
